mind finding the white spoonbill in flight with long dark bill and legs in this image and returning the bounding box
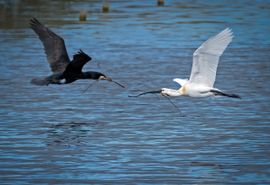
[130,28,240,98]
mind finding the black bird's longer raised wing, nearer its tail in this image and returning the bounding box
[30,18,70,73]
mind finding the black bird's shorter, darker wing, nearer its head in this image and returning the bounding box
[64,50,91,74]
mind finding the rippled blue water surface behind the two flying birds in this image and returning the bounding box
[0,0,270,184]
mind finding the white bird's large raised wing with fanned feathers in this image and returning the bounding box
[189,28,233,87]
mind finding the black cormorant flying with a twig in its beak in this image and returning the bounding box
[30,18,124,88]
